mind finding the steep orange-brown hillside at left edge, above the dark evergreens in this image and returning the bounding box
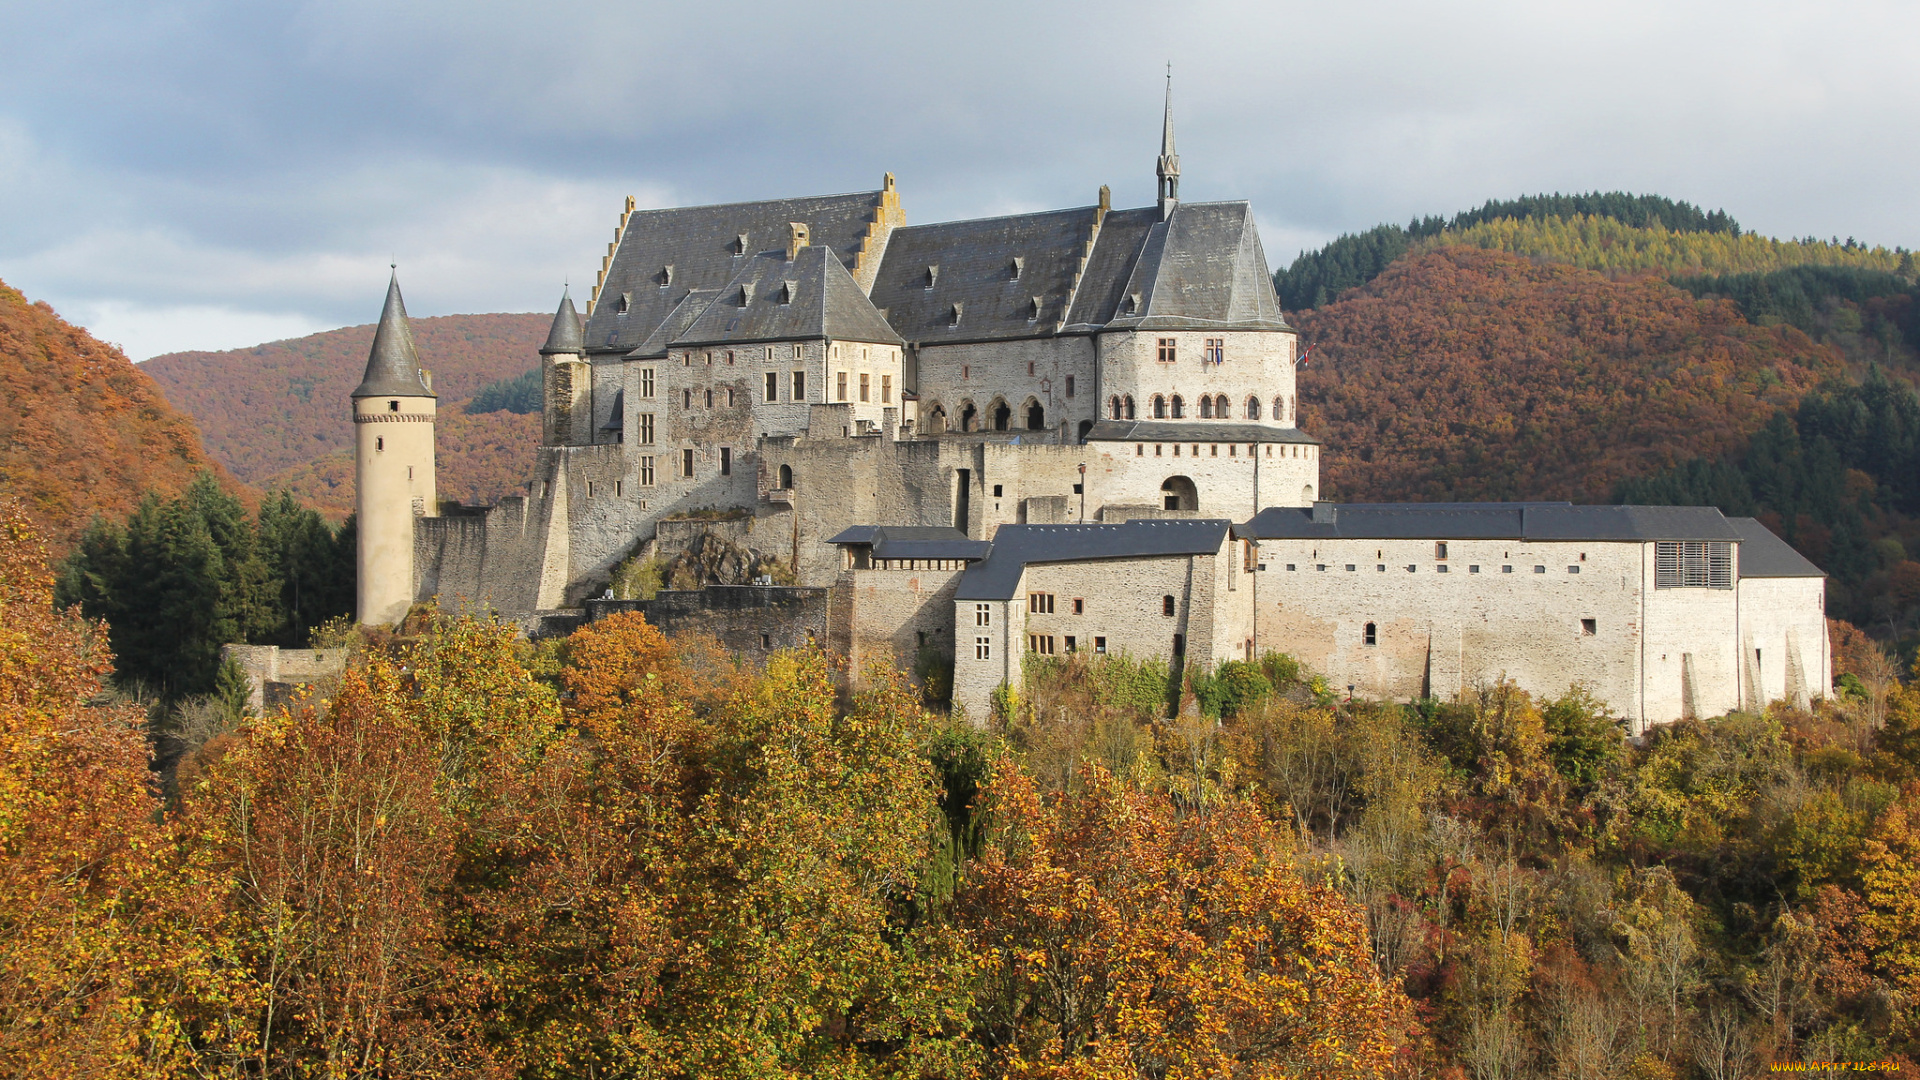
[0,282,240,553]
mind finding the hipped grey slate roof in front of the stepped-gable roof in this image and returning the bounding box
[672,244,906,345]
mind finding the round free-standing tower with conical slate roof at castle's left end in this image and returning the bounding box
[353,267,440,625]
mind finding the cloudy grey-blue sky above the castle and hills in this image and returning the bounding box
[0,0,1920,359]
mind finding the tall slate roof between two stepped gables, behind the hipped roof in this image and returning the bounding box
[586,190,881,354]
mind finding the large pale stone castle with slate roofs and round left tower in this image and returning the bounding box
[353,98,1832,728]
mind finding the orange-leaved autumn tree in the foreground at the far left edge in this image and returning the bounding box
[0,503,175,1078]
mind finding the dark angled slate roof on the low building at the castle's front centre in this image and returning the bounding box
[954,519,1233,600]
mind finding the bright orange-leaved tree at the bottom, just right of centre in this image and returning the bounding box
[960,761,1407,1080]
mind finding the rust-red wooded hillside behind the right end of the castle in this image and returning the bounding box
[1292,246,1841,502]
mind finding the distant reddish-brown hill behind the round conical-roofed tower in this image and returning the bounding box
[140,315,551,513]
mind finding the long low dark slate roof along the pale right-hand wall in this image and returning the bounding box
[1236,502,1741,542]
